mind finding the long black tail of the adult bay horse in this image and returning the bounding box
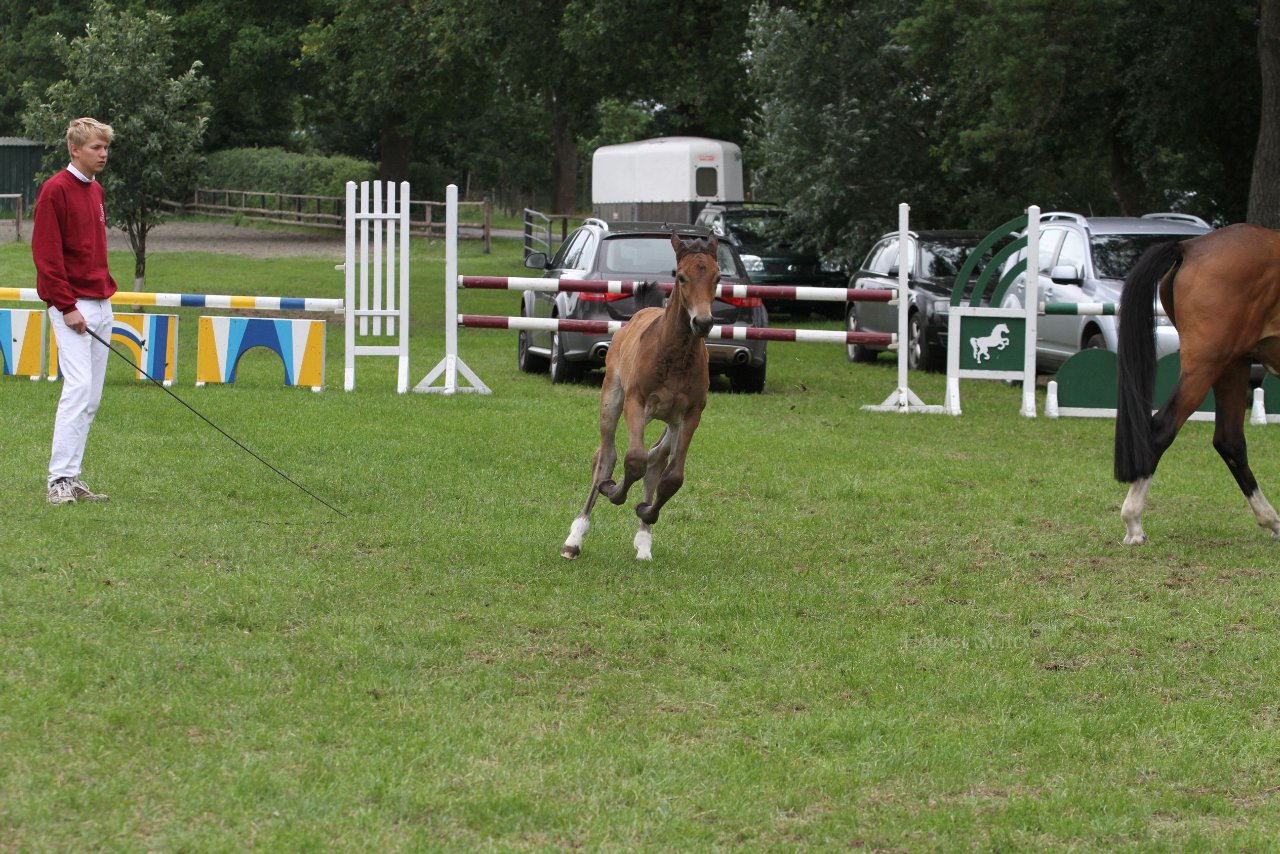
[1115,242,1183,483]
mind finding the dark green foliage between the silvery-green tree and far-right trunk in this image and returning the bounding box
[899,0,1258,222]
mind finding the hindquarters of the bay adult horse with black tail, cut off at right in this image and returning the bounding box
[1115,224,1280,543]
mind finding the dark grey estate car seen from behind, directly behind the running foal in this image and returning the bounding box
[517,219,769,393]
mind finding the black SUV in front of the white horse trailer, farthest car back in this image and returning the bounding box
[696,202,847,316]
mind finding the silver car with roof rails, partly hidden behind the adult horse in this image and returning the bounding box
[1002,211,1213,373]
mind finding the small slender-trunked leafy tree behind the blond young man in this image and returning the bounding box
[24,0,209,289]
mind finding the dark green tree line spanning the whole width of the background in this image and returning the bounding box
[0,0,1280,257]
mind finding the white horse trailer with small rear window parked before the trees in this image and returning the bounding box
[591,137,744,223]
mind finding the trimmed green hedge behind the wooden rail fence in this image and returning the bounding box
[200,149,378,197]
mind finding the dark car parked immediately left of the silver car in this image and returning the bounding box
[845,230,1011,370]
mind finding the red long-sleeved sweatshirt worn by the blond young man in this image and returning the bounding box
[31,169,115,314]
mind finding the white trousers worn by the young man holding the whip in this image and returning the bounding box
[49,300,113,484]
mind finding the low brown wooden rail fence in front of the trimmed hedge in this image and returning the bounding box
[180,188,493,254]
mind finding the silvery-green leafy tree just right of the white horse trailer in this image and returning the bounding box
[749,0,950,260]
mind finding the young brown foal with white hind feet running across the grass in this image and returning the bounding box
[561,233,719,561]
